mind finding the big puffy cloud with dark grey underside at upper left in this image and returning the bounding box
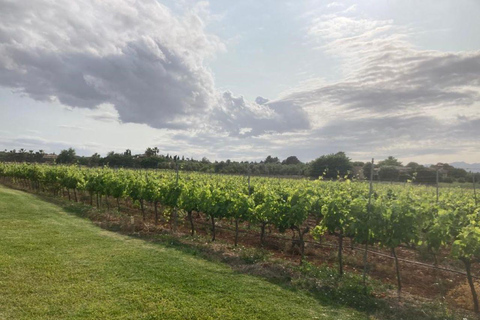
[0,0,308,134]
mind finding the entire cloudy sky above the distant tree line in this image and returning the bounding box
[0,0,480,163]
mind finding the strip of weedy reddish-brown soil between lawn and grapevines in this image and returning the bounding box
[21,189,463,320]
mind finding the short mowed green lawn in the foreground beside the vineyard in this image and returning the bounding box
[0,186,366,320]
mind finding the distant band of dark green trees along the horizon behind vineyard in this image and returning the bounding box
[0,147,480,184]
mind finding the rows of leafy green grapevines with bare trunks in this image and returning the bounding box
[0,163,480,313]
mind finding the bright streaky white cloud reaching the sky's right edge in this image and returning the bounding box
[296,10,480,117]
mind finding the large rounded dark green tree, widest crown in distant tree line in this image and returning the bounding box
[308,152,352,179]
